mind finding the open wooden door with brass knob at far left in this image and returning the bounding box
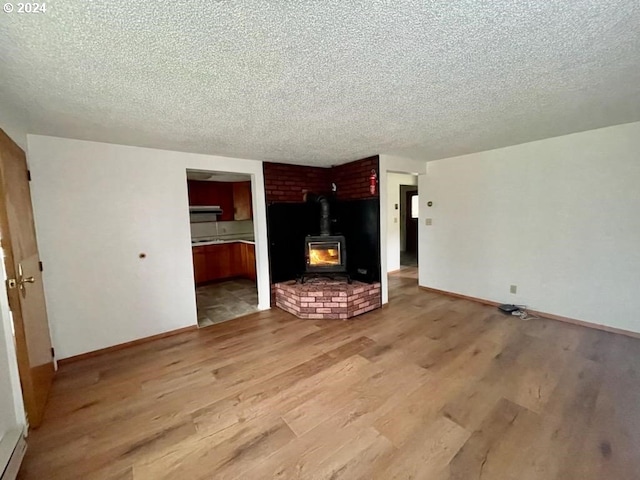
[0,130,55,427]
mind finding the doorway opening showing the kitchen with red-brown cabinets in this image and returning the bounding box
[187,170,258,327]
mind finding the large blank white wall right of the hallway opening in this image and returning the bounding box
[420,123,640,332]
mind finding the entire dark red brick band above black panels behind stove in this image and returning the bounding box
[263,155,379,203]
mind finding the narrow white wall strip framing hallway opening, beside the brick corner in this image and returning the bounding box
[378,154,427,304]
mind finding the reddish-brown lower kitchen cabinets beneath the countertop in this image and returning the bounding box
[192,242,256,285]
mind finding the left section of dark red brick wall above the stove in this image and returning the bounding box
[263,162,331,203]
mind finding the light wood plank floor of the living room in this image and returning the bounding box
[20,276,640,480]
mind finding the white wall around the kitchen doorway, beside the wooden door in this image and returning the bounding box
[28,135,270,358]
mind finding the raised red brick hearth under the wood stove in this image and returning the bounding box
[274,279,382,319]
